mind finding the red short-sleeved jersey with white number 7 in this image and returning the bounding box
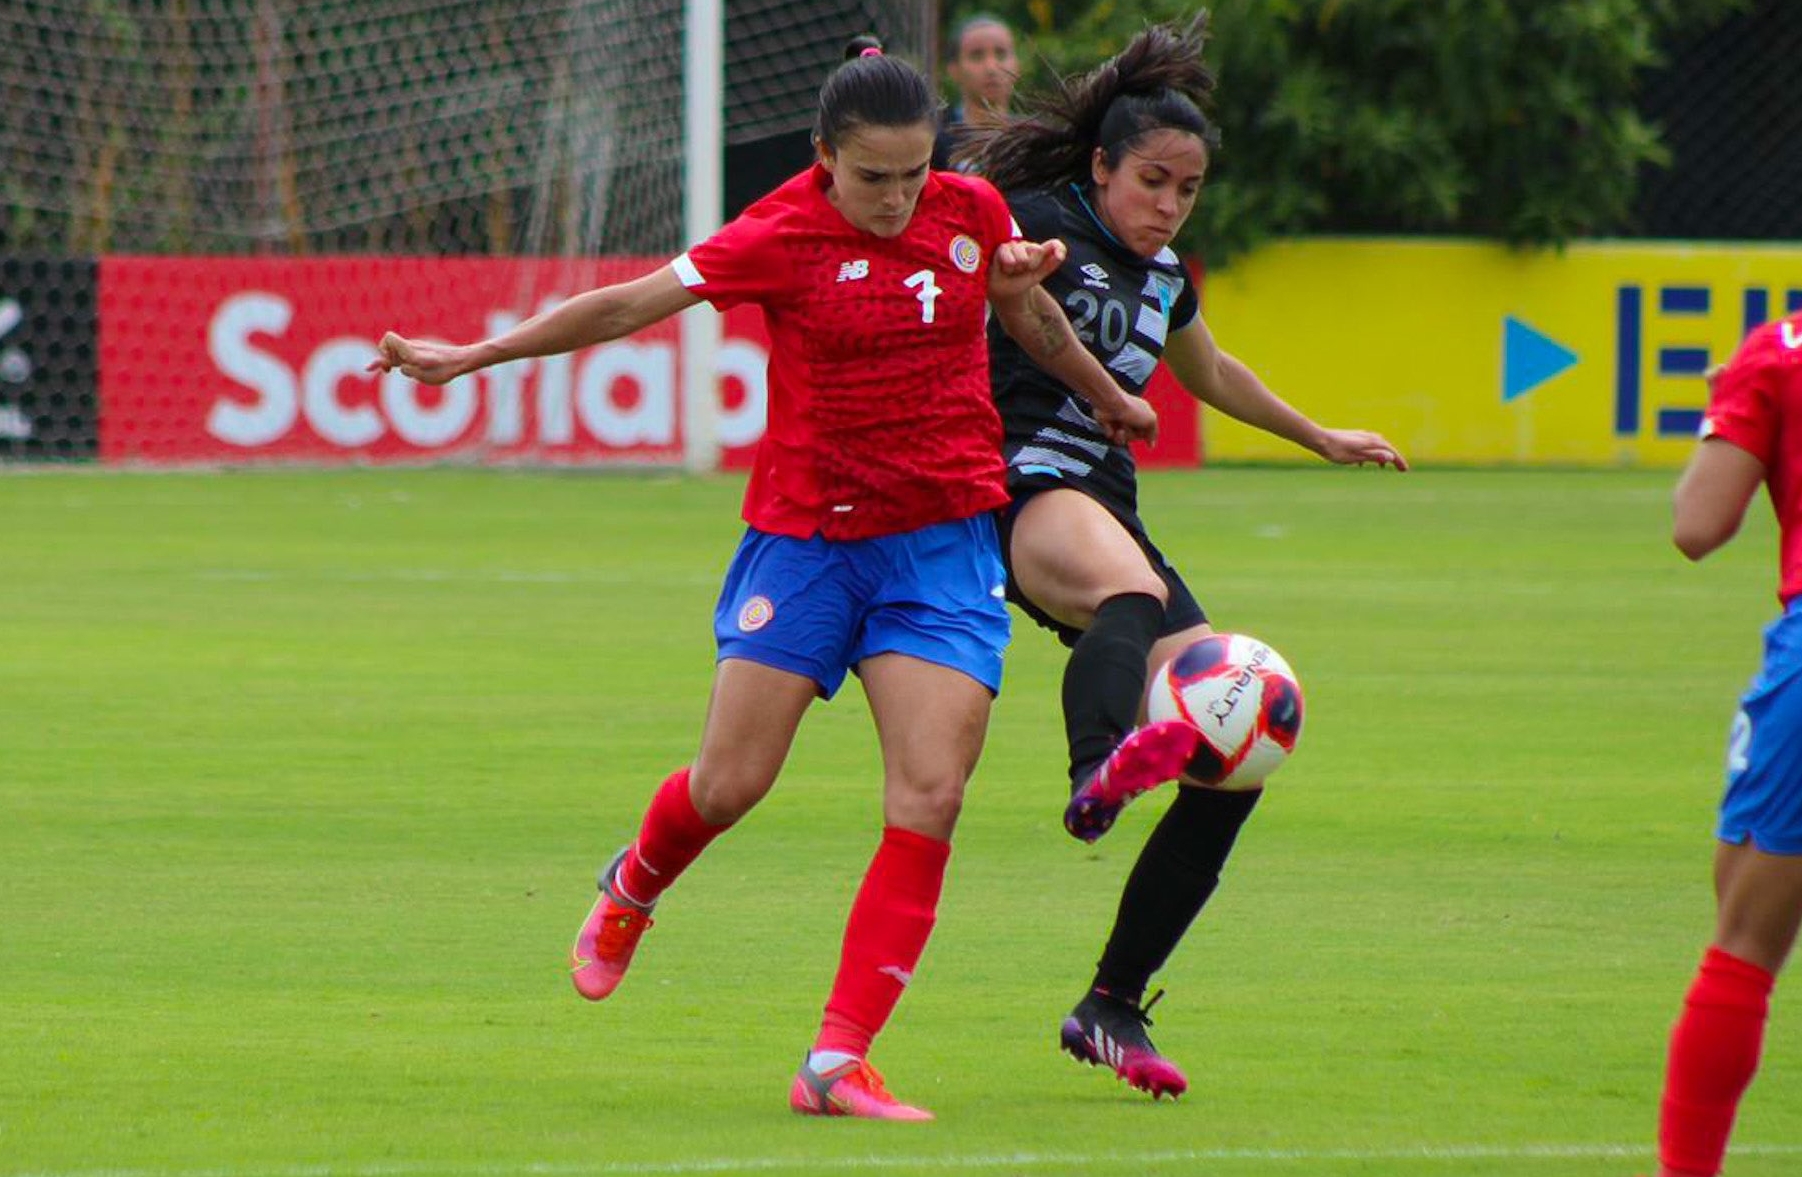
[674,164,1018,539]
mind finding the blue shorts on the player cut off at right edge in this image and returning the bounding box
[1716,598,1802,854]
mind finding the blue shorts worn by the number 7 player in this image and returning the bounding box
[714,512,1009,699]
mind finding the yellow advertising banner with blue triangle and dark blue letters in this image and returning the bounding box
[1202,238,1802,467]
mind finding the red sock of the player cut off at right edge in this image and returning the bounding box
[1658,948,1775,1177]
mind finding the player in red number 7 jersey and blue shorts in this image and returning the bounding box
[373,38,1157,1119]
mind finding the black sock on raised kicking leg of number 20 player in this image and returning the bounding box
[1063,593,1164,782]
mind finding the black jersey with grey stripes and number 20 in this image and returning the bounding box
[989,186,1200,510]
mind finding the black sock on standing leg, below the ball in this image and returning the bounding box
[1096,786,1263,1004]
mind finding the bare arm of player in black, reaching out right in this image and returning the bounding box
[1164,315,1407,470]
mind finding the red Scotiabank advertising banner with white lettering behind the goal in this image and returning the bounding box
[99,258,1197,467]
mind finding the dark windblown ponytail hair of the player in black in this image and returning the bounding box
[955,11,1220,191]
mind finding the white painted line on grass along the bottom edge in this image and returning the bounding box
[10,1143,1802,1177]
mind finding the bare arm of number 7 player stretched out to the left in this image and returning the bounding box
[369,265,701,384]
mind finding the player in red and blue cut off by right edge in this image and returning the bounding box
[1658,304,1802,1177]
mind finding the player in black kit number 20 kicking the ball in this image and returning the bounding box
[960,14,1407,1098]
